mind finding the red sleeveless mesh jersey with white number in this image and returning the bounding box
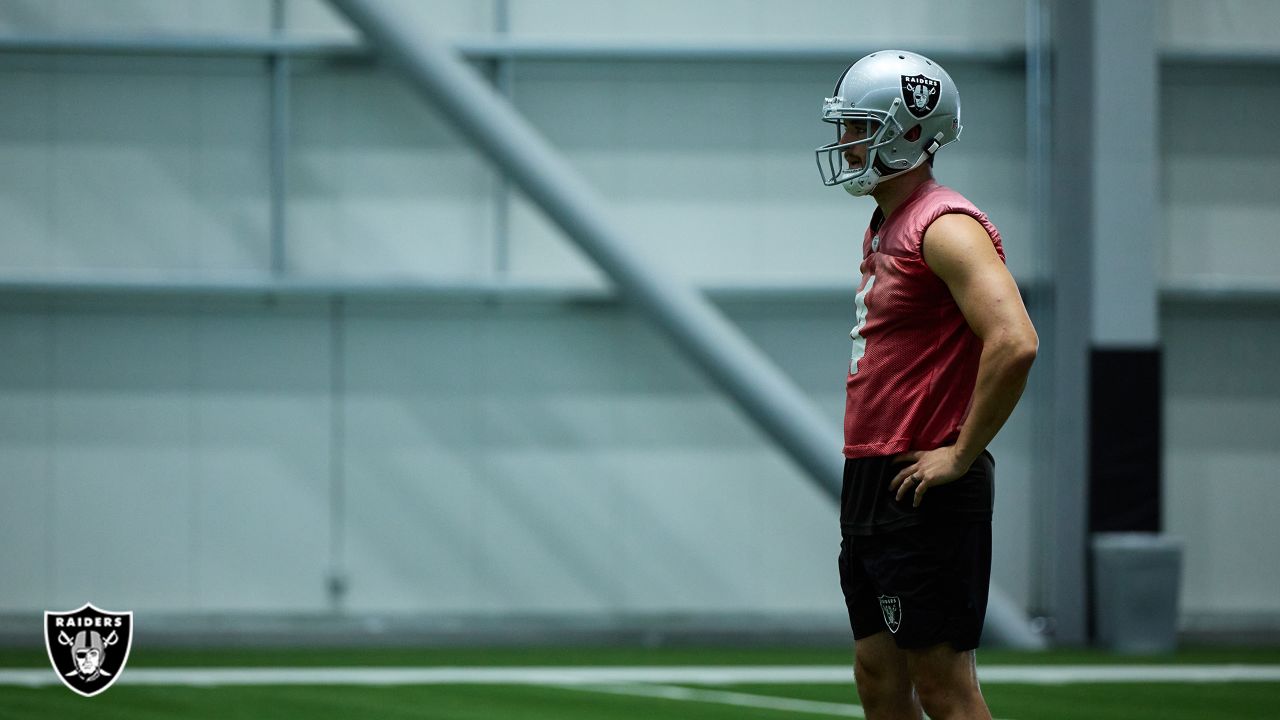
[845,179,1005,457]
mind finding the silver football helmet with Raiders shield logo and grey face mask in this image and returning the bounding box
[814,50,961,196]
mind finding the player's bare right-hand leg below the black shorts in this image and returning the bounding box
[901,643,991,720]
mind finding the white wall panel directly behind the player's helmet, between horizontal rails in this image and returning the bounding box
[511,63,1033,284]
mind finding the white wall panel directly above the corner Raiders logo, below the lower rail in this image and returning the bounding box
[47,304,195,610]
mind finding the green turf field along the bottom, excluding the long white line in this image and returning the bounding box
[0,648,1280,720]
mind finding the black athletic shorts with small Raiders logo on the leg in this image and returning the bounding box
[840,521,991,651]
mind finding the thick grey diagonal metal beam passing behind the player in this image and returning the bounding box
[330,0,1038,646]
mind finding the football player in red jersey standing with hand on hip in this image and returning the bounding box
[815,50,1038,720]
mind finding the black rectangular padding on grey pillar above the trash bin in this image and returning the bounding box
[1089,347,1162,533]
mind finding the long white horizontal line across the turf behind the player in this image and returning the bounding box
[0,665,1280,687]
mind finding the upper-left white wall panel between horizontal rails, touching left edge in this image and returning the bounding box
[0,58,268,272]
